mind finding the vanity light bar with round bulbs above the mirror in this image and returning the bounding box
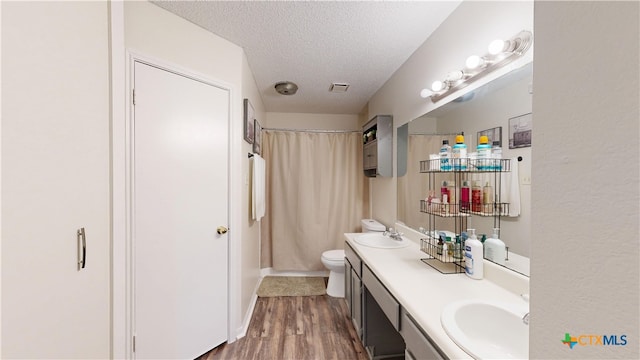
[420,30,533,102]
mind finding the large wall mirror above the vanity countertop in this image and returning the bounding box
[397,63,533,276]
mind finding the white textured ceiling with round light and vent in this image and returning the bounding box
[153,1,461,114]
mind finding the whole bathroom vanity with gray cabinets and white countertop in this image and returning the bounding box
[345,234,528,359]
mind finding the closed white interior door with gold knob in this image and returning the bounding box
[132,62,229,359]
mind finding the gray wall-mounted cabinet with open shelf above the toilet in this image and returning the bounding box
[362,115,393,177]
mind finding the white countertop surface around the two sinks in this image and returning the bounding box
[345,233,525,359]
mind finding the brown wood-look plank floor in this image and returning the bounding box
[197,295,368,360]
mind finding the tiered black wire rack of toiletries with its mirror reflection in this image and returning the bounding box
[420,148,511,274]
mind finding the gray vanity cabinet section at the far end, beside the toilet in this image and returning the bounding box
[344,243,362,340]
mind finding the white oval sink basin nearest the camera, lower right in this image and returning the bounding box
[440,300,529,359]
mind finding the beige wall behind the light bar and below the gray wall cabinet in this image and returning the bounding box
[368,1,533,231]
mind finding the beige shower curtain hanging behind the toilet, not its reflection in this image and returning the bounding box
[261,130,365,271]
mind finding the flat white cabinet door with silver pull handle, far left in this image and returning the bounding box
[0,1,110,359]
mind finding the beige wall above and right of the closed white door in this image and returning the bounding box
[124,1,262,340]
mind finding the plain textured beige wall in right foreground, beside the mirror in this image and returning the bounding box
[529,1,640,359]
